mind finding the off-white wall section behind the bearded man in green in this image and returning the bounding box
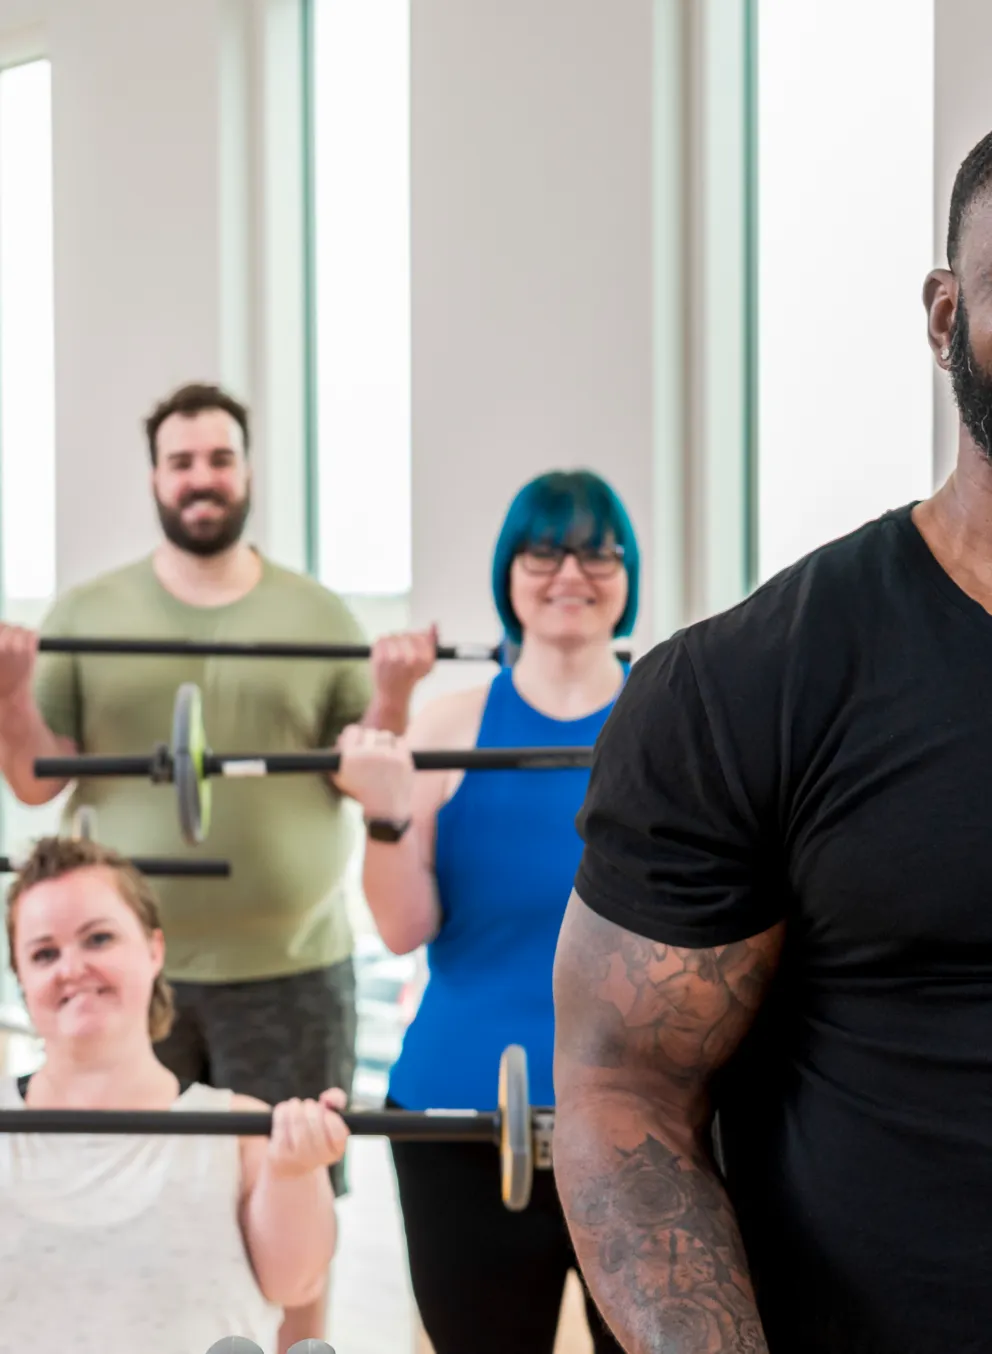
[49,0,228,585]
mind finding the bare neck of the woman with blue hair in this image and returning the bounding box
[513,635,624,719]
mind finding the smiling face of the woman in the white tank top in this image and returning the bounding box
[12,865,164,1045]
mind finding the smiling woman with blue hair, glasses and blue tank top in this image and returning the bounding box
[336,471,639,1354]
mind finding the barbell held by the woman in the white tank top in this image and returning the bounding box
[0,1044,555,1213]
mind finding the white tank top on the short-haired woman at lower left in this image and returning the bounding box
[0,1076,281,1354]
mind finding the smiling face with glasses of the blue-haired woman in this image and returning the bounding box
[510,538,628,647]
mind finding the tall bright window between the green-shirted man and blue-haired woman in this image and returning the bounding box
[311,0,411,597]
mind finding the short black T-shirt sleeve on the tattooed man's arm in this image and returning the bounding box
[575,632,785,949]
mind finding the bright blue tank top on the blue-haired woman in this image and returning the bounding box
[390,669,612,1110]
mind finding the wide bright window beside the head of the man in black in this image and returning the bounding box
[757,0,934,578]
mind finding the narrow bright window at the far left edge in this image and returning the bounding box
[0,61,55,608]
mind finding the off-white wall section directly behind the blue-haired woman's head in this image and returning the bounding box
[411,0,654,666]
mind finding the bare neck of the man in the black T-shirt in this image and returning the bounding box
[912,428,992,612]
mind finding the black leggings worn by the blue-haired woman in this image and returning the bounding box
[390,1102,623,1354]
